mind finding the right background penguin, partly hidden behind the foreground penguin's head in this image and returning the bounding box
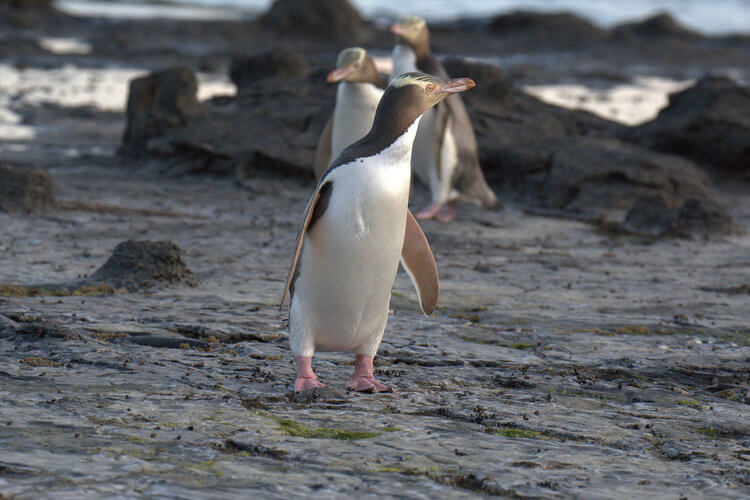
[391,17,498,222]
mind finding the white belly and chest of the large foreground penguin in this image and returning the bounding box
[289,147,413,356]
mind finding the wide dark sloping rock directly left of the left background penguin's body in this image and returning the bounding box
[148,76,335,180]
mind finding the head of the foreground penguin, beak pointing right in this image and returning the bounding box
[373,73,475,135]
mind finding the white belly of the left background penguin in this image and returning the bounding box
[331,82,383,159]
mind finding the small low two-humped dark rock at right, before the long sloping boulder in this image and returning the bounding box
[622,196,736,238]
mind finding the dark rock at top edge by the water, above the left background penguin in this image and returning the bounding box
[260,0,369,43]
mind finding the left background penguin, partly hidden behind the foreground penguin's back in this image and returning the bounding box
[314,47,388,179]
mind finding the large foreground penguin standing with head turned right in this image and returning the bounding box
[281,73,474,392]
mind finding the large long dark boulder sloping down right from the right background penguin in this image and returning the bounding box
[446,59,728,219]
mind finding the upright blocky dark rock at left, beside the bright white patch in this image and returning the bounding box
[122,66,201,152]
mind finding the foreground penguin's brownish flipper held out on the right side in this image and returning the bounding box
[401,210,440,316]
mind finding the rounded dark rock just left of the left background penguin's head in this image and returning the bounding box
[229,47,310,89]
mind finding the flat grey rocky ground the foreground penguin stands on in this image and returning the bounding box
[0,60,750,498]
